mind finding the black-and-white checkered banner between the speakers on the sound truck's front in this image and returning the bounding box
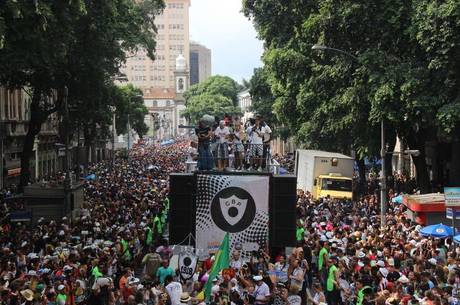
[196,175,270,256]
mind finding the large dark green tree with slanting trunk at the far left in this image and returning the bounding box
[0,0,164,185]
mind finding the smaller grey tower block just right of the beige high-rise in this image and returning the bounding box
[190,41,211,85]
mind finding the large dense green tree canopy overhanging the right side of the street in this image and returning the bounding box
[243,0,460,189]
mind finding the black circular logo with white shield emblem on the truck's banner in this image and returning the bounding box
[211,186,256,233]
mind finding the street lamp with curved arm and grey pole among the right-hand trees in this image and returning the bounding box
[311,44,387,228]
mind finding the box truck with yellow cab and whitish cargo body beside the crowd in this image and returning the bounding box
[295,149,354,199]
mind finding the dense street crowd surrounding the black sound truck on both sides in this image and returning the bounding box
[0,141,460,305]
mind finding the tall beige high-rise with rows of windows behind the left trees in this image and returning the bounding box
[121,0,190,94]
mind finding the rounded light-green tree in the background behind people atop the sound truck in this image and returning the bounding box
[182,75,241,123]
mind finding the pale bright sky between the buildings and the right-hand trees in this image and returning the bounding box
[190,0,263,82]
